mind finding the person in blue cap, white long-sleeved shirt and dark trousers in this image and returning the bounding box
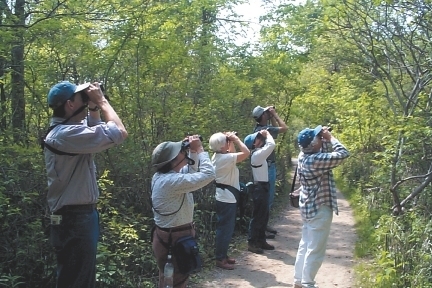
[244,130,275,254]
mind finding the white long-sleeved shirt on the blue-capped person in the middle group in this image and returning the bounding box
[251,134,276,182]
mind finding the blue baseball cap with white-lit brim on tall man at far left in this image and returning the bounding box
[48,81,90,109]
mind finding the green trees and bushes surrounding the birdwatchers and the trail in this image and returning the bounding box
[0,0,432,288]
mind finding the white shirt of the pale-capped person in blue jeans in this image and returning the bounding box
[212,153,240,203]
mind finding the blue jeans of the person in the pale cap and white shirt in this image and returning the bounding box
[216,201,237,260]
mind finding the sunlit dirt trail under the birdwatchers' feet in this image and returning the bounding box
[191,186,357,288]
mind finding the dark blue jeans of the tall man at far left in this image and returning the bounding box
[50,209,99,288]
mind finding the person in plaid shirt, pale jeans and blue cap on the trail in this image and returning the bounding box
[294,125,349,288]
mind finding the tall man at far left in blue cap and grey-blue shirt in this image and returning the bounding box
[43,81,127,288]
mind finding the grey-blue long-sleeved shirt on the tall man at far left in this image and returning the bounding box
[44,116,124,212]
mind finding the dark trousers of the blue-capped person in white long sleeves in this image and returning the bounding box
[248,184,269,244]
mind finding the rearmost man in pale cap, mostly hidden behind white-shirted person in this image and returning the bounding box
[252,106,288,238]
